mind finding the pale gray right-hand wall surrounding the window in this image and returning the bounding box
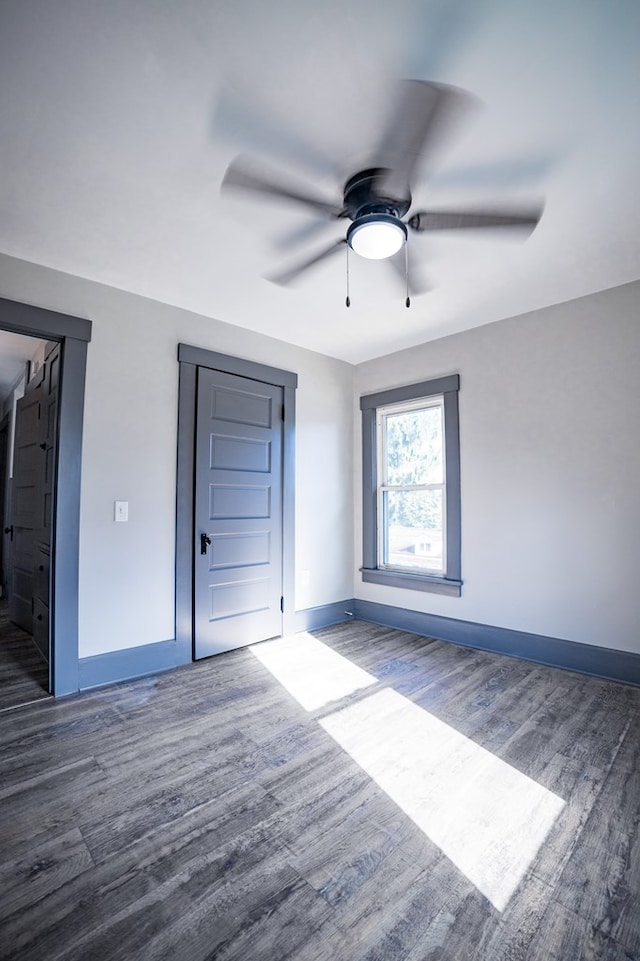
[354,283,640,653]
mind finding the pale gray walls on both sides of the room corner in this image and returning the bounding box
[0,256,640,657]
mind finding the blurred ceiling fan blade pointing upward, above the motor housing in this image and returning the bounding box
[376,80,475,199]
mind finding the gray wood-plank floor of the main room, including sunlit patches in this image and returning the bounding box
[0,621,640,961]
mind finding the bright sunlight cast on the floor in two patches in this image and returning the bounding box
[251,634,565,911]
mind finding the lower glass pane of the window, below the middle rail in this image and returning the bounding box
[382,490,444,572]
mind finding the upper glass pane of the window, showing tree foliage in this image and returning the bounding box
[384,406,444,485]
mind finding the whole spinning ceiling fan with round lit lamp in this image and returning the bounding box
[222,80,542,307]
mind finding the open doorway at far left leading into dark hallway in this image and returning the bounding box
[0,330,53,710]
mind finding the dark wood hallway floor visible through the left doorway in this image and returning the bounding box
[0,600,49,711]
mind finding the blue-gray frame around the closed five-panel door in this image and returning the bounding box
[176,344,298,661]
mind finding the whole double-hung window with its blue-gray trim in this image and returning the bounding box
[360,374,462,597]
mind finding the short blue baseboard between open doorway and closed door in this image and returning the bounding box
[79,641,186,691]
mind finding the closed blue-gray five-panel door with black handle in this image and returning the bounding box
[194,367,283,658]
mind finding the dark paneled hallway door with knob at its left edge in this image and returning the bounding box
[9,379,42,636]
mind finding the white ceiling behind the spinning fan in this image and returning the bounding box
[0,0,640,362]
